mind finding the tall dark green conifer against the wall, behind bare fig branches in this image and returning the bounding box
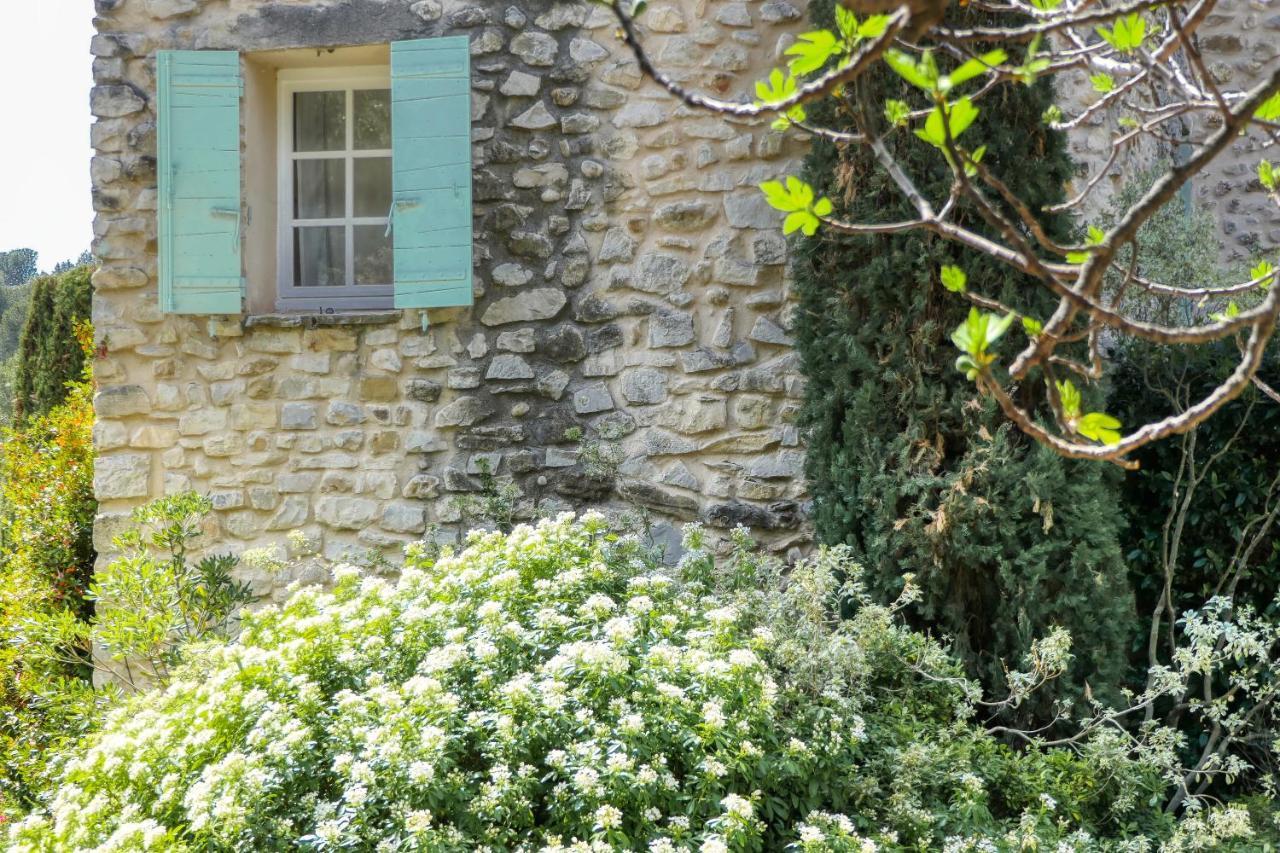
[795,0,1133,693]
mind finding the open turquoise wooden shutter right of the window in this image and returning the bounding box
[392,36,471,321]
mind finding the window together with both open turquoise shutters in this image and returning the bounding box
[156,36,472,323]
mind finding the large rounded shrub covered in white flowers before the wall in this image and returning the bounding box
[6,515,1269,853]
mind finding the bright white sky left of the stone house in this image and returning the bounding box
[0,0,93,270]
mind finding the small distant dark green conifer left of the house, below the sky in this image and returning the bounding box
[13,265,93,421]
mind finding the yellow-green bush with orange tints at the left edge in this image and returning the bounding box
[0,325,97,809]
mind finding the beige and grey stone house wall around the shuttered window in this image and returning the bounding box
[92,0,806,587]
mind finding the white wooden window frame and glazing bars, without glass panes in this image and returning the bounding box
[275,65,394,313]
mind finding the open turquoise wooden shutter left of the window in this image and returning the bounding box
[156,50,243,314]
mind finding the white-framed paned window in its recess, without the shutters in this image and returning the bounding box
[276,67,393,311]
